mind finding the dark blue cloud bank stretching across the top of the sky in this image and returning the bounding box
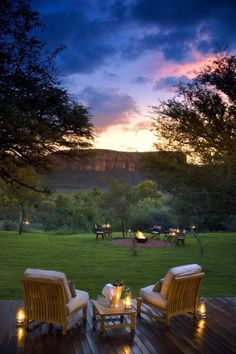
[32,0,236,75]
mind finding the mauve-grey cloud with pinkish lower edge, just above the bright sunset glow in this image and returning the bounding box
[80,86,139,129]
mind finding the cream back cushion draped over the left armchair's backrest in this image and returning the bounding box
[23,268,71,302]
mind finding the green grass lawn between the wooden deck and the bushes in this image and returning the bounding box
[0,232,236,299]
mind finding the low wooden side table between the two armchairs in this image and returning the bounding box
[92,300,136,333]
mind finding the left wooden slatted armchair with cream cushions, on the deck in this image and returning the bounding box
[22,268,89,334]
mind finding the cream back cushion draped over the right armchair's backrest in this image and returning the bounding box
[160,264,202,298]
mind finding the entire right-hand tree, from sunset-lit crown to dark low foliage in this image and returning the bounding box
[152,53,236,229]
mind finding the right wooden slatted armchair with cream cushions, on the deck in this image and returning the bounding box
[137,264,204,325]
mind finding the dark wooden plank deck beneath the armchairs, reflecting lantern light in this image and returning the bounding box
[0,297,236,354]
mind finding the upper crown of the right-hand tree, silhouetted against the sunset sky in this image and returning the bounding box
[153,53,236,163]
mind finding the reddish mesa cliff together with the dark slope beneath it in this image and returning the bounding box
[44,149,185,192]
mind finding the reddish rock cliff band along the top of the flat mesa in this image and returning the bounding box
[49,149,186,172]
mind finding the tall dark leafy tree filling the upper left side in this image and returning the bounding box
[0,0,93,187]
